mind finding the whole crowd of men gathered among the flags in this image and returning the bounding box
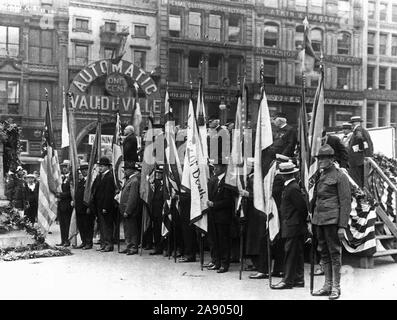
[4,113,373,299]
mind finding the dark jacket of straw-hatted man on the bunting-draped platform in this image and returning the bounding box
[349,126,374,167]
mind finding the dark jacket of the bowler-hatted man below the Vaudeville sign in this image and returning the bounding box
[92,171,116,214]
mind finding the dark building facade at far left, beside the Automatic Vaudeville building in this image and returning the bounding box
[0,0,69,170]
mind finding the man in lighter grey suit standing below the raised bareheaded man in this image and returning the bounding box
[119,163,142,255]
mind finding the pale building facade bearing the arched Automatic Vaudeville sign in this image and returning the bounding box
[68,0,160,158]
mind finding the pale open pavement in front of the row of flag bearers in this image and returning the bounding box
[0,225,397,300]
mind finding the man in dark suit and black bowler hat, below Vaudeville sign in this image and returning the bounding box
[90,157,116,252]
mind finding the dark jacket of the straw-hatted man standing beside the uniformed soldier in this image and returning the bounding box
[280,181,307,238]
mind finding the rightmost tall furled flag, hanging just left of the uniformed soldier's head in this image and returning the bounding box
[308,71,324,200]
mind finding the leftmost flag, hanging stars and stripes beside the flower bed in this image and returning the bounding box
[37,91,62,234]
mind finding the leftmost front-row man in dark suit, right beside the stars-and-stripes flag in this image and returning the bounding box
[57,160,73,247]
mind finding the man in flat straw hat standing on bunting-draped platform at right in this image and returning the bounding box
[348,116,374,188]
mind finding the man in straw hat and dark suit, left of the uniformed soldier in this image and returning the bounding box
[272,162,307,289]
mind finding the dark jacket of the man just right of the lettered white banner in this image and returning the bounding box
[208,175,234,224]
